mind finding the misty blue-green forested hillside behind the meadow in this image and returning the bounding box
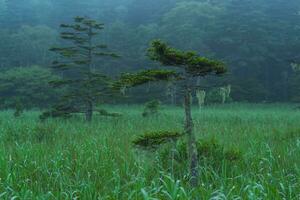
[0,0,300,106]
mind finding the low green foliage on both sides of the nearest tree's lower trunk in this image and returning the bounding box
[132,131,243,177]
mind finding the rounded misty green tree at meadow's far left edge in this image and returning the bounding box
[0,66,58,110]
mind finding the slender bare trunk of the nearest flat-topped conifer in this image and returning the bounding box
[184,80,199,187]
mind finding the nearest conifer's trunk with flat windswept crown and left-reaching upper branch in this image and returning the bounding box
[116,40,226,187]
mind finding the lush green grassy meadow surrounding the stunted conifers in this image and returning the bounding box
[0,104,300,200]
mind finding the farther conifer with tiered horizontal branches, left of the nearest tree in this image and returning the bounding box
[45,17,117,121]
